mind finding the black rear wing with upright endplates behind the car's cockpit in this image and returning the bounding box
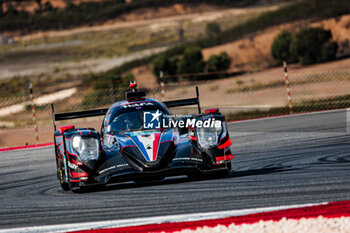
[51,86,201,131]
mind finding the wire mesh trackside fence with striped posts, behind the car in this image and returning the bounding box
[0,68,350,147]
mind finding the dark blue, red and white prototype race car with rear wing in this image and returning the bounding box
[52,83,233,191]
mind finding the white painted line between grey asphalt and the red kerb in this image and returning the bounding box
[0,202,328,233]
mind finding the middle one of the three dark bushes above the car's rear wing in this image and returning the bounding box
[177,46,205,74]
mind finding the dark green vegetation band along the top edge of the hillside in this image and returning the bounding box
[0,0,289,34]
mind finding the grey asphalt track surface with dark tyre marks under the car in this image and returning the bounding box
[0,110,350,229]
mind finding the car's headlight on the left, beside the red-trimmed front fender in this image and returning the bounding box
[72,136,100,160]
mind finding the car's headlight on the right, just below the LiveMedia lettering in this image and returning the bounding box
[196,121,222,148]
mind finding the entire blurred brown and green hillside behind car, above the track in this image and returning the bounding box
[0,0,350,146]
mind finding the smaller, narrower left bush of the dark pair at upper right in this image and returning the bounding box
[271,30,296,64]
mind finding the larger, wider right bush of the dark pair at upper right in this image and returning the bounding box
[290,28,338,64]
